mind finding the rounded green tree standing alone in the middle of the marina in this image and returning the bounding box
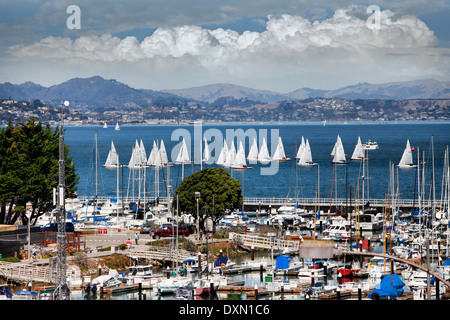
[174,168,244,223]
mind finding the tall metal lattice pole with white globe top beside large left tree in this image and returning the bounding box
[53,101,69,300]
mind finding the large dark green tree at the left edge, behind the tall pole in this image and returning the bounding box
[0,119,78,224]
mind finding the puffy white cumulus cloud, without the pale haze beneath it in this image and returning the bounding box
[9,6,448,88]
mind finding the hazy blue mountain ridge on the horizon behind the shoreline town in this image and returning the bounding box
[0,76,450,109]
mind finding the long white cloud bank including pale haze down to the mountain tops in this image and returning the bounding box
[8,5,450,92]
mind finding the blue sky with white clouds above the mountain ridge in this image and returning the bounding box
[0,0,450,93]
